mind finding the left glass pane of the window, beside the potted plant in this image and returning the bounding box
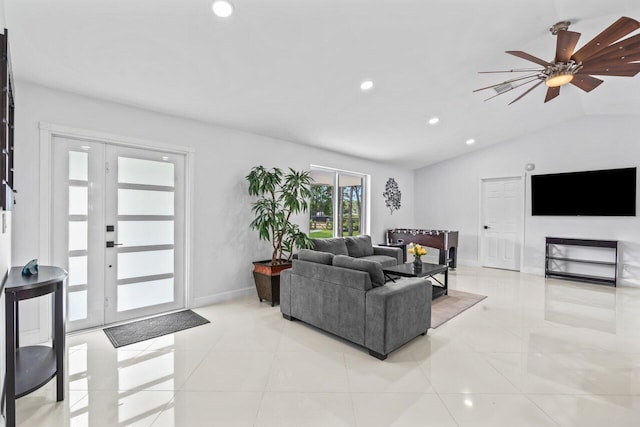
[309,170,335,239]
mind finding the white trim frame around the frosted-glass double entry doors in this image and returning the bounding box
[38,122,195,314]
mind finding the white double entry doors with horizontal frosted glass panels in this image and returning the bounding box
[52,137,185,331]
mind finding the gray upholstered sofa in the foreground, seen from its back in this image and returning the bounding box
[280,244,432,360]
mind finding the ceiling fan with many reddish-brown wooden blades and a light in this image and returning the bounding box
[474,16,640,105]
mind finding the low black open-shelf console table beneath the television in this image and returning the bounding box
[544,237,618,286]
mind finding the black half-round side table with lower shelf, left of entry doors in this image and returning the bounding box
[4,266,67,427]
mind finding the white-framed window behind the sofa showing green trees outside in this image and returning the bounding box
[309,166,368,239]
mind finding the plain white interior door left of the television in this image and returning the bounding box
[480,177,524,271]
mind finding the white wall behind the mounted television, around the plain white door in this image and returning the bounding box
[415,116,640,284]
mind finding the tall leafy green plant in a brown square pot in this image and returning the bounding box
[246,166,311,306]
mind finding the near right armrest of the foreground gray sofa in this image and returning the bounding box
[365,278,433,355]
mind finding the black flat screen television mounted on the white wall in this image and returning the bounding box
[531,168,637,216]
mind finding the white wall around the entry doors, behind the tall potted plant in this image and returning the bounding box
[13,81,414,305]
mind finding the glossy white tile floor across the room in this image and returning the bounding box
[17,267,640,427]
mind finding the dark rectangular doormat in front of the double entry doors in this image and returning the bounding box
[103,310,209,348]
